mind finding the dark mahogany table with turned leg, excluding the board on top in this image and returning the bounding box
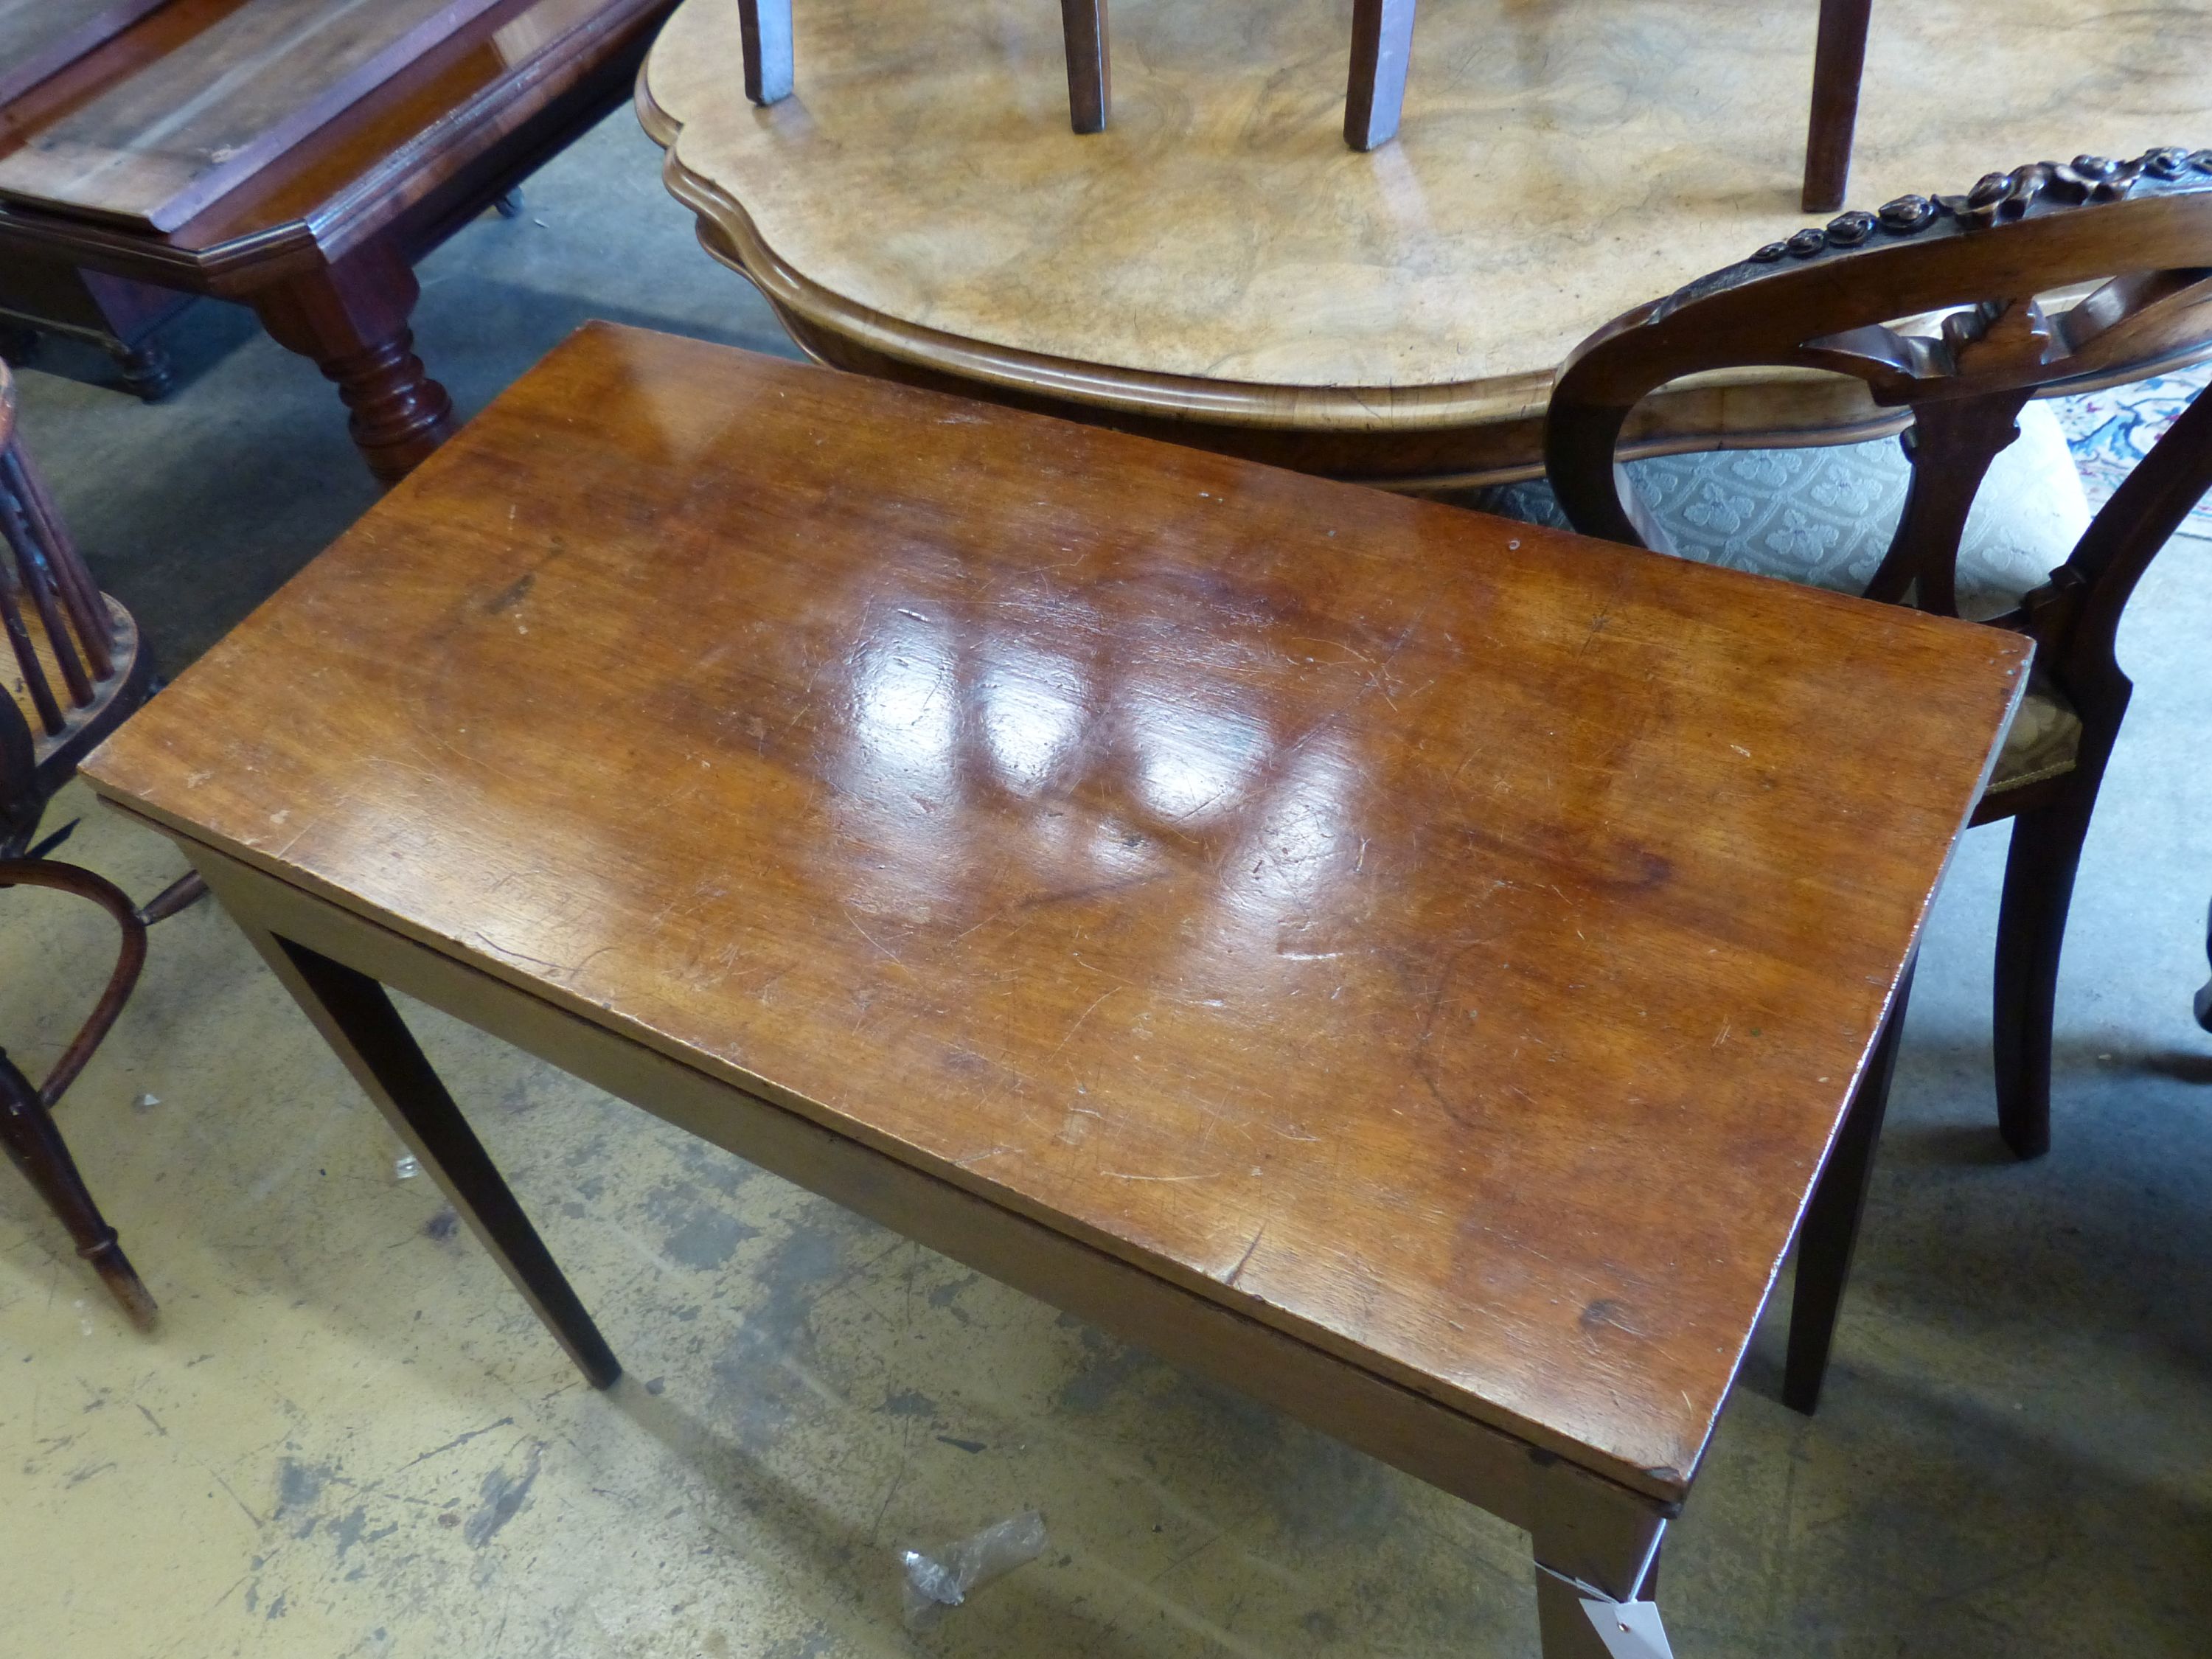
[0,0,675,480]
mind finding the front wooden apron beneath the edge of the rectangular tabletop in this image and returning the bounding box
[168,827,1679,1599]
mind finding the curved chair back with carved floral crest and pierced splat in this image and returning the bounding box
[1544,148,2212,666]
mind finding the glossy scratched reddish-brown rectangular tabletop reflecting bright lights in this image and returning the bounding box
[84,325,2028,1498]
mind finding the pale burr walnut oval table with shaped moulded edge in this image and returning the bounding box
[639,0,2212,489]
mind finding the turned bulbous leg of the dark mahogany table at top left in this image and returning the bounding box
[252,243,453,484]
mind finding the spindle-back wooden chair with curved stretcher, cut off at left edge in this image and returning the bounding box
[0,367,204,1327]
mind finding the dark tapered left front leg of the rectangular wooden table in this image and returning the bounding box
[239,918,622,1389]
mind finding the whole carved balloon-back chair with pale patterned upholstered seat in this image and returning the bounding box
[1531,148,2212,1157]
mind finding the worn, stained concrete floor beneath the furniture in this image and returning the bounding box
[0,113,2212,1659]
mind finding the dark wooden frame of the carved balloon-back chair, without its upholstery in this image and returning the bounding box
[1546,148,2212,1186]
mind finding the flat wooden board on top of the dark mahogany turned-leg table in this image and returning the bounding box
[0,0,507,230]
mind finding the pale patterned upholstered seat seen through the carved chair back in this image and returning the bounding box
[1475,403,2090,810]
